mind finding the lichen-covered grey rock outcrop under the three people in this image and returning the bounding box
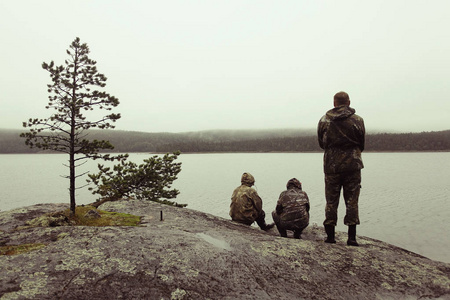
[0,201,450,299]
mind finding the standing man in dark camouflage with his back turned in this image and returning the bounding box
[317,92,365,246]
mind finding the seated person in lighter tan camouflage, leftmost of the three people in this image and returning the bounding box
[230,173,275,230]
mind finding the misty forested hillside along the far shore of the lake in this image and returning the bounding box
[0,129,450,153]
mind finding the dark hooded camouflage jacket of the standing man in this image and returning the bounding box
[317,105,365,174]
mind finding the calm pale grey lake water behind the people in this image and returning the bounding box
[0,152,450,263]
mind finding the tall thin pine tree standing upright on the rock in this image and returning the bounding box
[20,37,122,213]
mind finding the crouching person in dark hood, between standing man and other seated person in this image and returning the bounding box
[272,178,309,239]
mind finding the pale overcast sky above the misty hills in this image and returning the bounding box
[0,0,450,132]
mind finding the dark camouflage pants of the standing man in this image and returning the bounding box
[323,170,361,226]
